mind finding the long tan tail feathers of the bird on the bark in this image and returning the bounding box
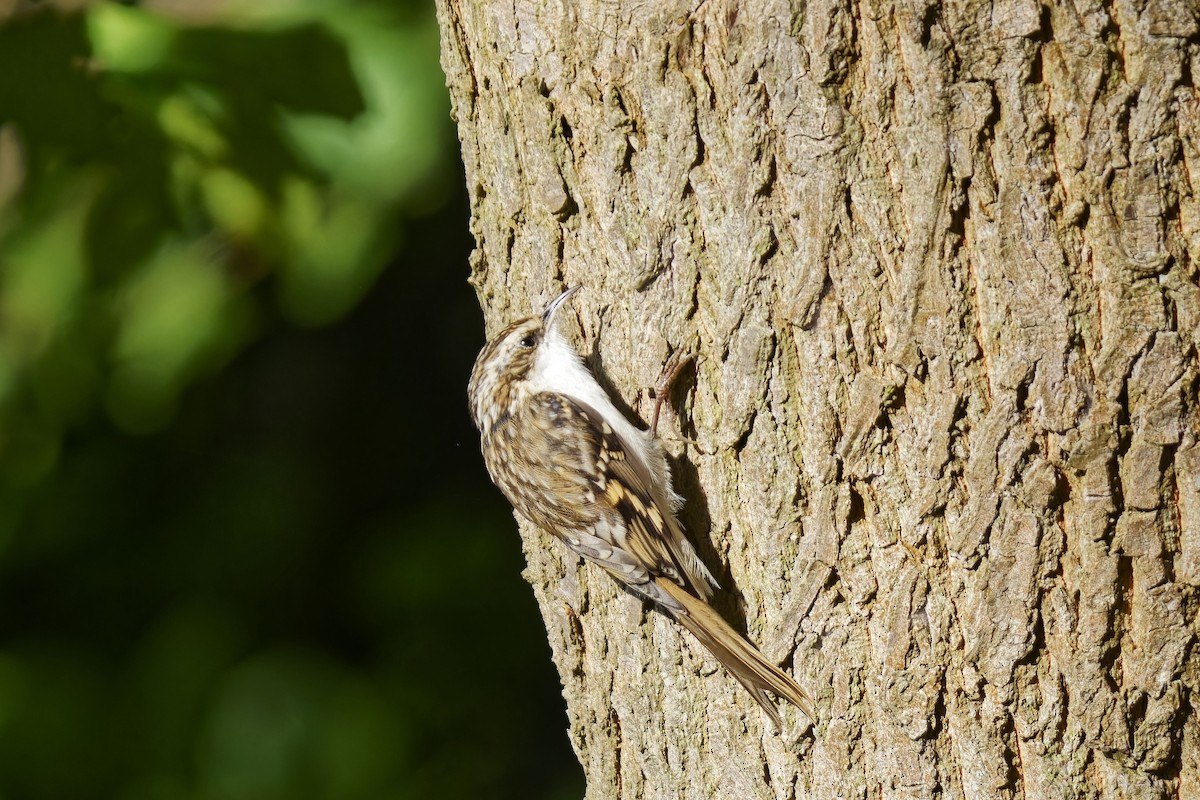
[655,578,817,730]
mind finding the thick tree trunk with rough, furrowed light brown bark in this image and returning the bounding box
[439,0,1200,800]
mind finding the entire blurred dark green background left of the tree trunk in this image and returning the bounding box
[0,0,582,800]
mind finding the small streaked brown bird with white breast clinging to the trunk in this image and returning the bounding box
[467,285,816,730]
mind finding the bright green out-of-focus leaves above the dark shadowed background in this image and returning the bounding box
[0,0,449,455]
